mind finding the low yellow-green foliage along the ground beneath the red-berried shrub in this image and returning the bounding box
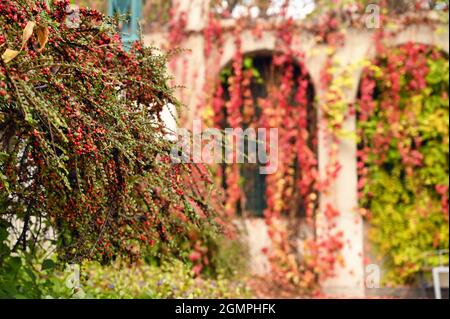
[0,218,250,299]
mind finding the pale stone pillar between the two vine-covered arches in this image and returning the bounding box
[318,30,373,297]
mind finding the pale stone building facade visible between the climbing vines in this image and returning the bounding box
[106,0,449,297]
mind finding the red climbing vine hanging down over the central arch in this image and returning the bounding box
[196,6,342,292]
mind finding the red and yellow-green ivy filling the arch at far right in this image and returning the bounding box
[358,43,449,284]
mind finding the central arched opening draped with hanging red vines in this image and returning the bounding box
[215,51,318,219]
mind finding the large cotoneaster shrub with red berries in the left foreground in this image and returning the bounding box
[0,0,215,267]
